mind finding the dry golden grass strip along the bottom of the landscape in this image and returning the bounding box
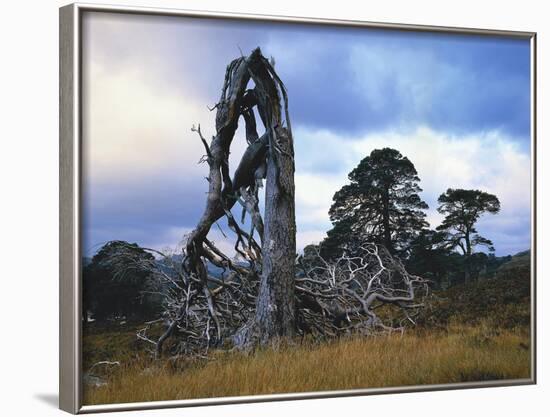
[84,324,530,404]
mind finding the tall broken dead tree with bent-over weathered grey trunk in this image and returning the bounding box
[153,48,296,354]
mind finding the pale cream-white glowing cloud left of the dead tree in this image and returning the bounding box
[83,62,218,181]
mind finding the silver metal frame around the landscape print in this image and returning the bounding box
[59,3,537,414]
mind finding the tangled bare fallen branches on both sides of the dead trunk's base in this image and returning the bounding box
[110,239,429,356]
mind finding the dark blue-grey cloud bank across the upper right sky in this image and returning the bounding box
[267,28,530,141]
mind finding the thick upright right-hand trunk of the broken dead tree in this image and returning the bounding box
[233,49,296,348]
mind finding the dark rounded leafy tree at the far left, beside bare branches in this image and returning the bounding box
[83,241,161,321]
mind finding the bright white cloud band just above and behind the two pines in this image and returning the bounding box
[353,126,530,210]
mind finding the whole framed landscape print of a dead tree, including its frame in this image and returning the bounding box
[60,4,536,413]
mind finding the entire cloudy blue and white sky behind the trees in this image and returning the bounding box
[82,12,531,256]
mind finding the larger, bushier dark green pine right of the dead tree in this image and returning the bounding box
[321,148,428,258]
